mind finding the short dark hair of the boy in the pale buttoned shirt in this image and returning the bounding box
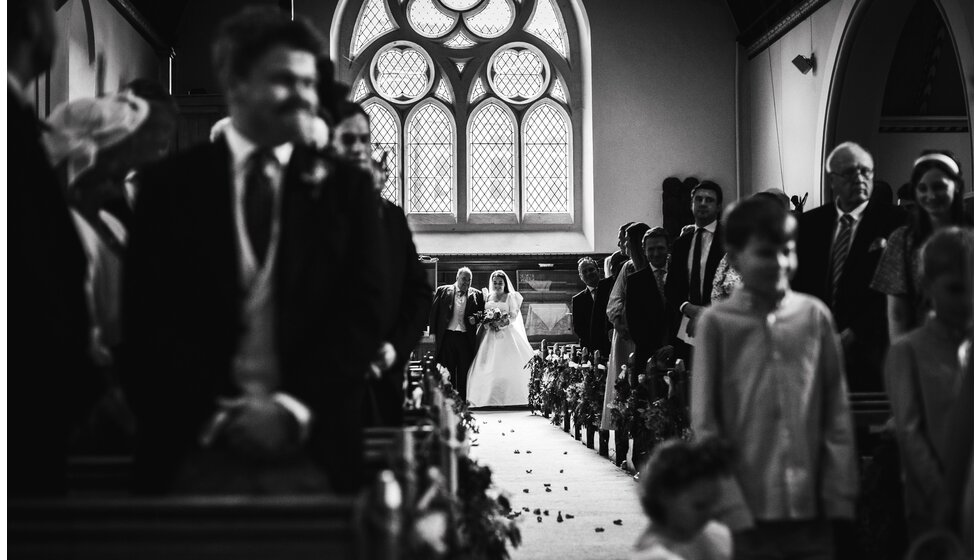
[722,196,796,252]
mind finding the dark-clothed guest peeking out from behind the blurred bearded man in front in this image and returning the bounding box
[332,99,432,426]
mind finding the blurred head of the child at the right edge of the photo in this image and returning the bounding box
[919,227,973,327]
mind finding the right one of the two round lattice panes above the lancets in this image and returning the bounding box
[487,43,551,103]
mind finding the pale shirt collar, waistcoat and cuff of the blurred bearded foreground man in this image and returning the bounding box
[224,125,312,437]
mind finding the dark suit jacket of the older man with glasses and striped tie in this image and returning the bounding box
[792,203,905,391]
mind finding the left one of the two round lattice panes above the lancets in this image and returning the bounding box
[370,41,435,104]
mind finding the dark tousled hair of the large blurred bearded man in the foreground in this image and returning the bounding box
[211,7,324,89]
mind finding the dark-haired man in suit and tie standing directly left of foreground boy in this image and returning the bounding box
[664,181,725,363]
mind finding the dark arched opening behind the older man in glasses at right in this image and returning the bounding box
[823,0,973,200]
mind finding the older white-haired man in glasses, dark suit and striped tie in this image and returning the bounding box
[793,142,905,391]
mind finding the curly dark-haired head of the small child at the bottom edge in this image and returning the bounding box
[640,438,732,540]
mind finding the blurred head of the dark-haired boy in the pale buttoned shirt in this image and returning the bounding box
[722,196,797,294]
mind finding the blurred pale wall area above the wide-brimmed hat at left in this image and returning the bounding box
[49,0,168,108]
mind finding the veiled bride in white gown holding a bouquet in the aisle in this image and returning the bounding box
[466,270,534,406]
